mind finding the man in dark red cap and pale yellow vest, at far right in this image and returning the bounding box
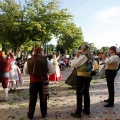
[103,46,119,107]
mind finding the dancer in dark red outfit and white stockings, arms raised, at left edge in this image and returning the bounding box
[0,51,14,102]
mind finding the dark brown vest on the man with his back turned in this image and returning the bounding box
[27,56,48,76]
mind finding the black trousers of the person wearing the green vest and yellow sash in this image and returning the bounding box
[76,76,92,114]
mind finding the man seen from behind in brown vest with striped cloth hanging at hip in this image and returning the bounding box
[23,47,55,119]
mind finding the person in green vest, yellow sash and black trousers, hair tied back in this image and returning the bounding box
[71,44,93,118]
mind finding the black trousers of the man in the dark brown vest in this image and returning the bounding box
[28,82,47,116]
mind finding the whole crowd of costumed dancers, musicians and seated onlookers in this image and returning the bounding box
[0,44,120,119]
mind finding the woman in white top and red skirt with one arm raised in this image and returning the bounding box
[49,51,62,81]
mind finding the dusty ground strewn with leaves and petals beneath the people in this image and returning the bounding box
[0,70,120,120]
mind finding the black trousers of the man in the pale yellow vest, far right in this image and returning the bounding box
[105,70,117,104]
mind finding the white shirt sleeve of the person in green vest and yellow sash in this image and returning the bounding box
[71,55,88,68]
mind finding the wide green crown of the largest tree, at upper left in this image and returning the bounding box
[0,0,72,51]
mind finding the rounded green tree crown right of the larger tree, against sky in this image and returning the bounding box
[58,23,83,52]
